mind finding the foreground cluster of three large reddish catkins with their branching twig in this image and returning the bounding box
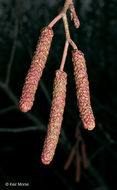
[19,0,95,164]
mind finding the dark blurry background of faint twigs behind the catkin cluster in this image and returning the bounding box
[0,0,117,190]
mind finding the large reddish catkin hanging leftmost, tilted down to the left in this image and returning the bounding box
[19,27,54,112]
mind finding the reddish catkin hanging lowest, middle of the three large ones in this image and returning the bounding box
[41,70,67,164]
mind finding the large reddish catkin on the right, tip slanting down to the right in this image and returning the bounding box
[72,50,95,130]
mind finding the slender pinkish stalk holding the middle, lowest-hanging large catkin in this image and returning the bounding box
[60,40,69,71]
